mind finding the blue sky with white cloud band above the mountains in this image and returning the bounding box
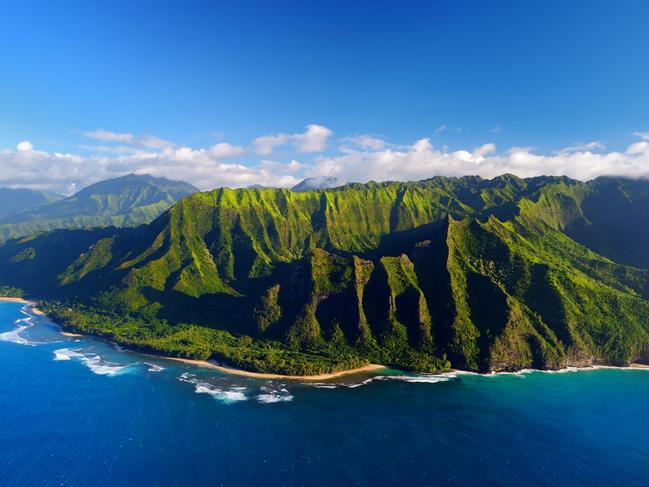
[0,0,649,194]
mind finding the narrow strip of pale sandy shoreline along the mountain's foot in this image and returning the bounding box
[5,296,649,381]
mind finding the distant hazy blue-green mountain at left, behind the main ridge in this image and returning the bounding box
[0,174,198,241]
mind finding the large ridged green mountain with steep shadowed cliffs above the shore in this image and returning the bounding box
[0,175,649,373]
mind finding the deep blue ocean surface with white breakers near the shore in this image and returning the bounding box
[0,302,649,486]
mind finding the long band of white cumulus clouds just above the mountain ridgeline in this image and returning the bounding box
[0,125,649,193]
